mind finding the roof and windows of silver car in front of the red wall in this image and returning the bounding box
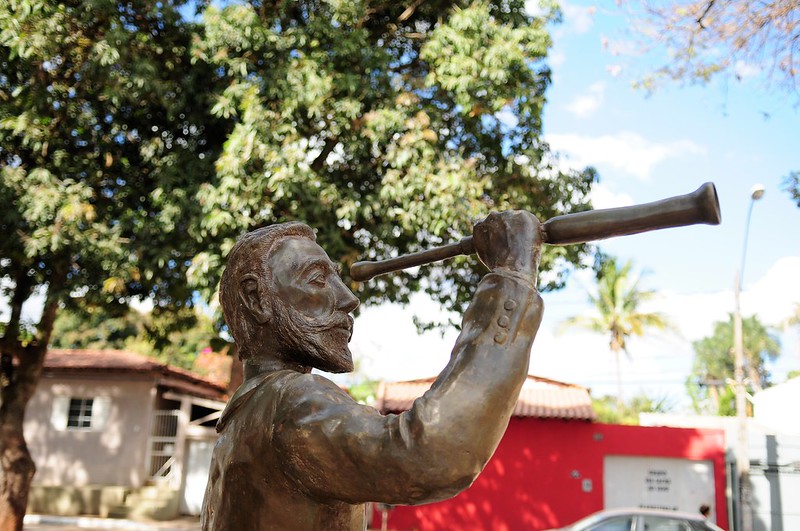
[562,508,722,531]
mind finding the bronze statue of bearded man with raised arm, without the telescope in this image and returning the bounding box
[202,211,542,531]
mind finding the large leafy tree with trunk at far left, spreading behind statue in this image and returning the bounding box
[0,0,597,529]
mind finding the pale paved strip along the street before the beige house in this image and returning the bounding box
[25,514,200,531]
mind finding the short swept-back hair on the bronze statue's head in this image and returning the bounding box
[219,221,316,360]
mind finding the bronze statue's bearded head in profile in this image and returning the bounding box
[219,222,358,372]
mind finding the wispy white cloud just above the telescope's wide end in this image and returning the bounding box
[545,131,705,180]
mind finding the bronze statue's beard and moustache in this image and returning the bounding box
[272,300,353,373]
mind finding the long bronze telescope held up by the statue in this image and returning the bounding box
[350,183,721,281]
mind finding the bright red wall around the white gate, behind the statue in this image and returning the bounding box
[373,418,728,531]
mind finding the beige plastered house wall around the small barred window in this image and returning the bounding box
[25,375,155,487]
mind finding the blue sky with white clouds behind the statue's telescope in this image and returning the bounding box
[353,1,800,409]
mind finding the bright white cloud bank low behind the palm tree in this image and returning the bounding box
[530,256,800,405]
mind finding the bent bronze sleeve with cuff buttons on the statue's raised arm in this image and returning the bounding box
[273,273,542,505]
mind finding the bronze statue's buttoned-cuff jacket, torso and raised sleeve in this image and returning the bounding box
[202,274,542,531]
